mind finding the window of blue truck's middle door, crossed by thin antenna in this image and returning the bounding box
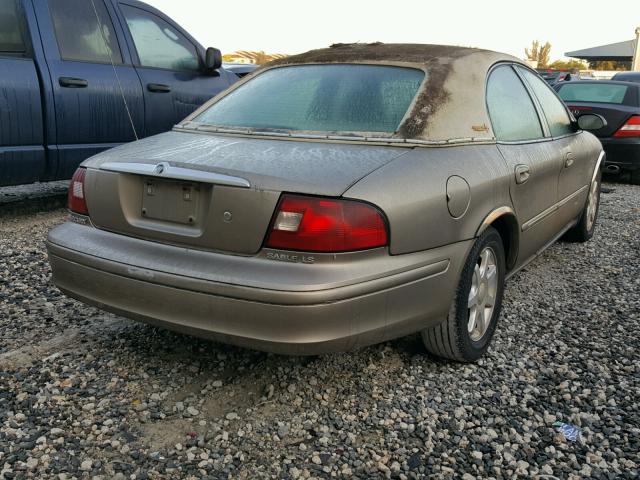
[49,0,122,64]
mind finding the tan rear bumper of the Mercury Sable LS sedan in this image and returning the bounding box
[47,223,472,355]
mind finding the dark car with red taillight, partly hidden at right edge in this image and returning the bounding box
[555,80,640,185]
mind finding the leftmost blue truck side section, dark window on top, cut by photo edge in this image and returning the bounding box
[0,0,46,186]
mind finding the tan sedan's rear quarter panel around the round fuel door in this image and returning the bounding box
[344,145,512,254]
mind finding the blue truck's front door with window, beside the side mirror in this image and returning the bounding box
[119,2,237,135]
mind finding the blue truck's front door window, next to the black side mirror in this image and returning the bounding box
[121,5,200,71]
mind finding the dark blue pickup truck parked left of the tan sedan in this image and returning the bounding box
[0,0,238,186]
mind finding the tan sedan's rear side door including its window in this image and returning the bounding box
[487,64,561,264]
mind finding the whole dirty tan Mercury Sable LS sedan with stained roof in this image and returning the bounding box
[47,44,602,361]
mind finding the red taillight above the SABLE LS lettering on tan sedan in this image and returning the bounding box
[266,195,387,252]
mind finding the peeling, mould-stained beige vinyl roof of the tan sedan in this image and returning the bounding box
[187,43,522,142]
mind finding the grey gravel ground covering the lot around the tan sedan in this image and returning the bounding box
[0,185,640,479]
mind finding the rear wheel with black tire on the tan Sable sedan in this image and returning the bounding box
[422,227,506,362]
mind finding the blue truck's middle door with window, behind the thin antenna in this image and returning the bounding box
[34,0,144,178]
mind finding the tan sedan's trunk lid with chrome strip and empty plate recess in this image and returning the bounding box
[83,132,409,255]
